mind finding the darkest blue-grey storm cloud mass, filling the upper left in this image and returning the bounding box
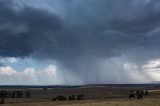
[0,1,79,57]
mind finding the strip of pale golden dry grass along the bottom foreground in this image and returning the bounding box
[2,98,160,106]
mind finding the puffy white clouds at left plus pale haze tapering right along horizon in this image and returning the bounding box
[0,64,84,85]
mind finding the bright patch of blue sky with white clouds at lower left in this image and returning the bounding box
[0,57,84,85]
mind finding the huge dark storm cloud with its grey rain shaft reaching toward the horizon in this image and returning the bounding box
[0,0,160,83]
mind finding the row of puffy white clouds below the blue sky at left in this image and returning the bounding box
[0,65,60,85]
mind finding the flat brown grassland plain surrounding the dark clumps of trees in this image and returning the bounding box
[0,87,160,106]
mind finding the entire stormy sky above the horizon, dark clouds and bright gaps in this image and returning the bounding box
[0,0,160,85]
